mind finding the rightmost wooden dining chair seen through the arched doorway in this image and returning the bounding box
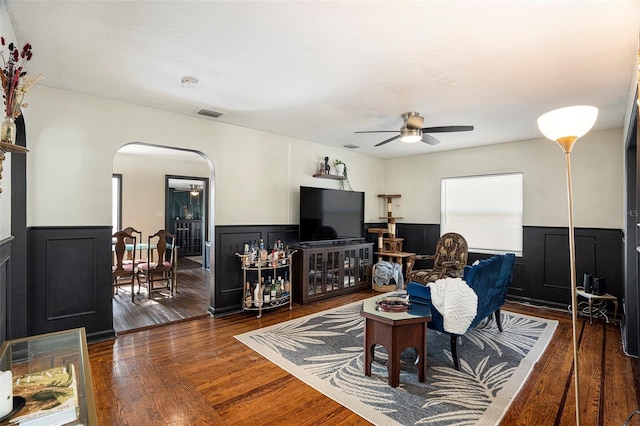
[136,229,175,299]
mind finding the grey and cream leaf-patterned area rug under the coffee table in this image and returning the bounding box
[235,296,557,426]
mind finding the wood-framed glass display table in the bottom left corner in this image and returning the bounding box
[0,328,98,426]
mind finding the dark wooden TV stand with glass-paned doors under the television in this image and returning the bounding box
[294,243,373,304]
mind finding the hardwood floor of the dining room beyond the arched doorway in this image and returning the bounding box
[113,257,209,334]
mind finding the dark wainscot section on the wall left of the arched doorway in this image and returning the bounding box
[27,226,115,341]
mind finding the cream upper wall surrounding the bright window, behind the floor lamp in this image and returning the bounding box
[385,129,623,228]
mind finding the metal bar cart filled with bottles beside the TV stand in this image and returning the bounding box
[238,251,295,318]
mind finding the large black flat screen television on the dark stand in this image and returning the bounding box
[300,186,364,244]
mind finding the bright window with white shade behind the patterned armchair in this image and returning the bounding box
[440,173,523,255]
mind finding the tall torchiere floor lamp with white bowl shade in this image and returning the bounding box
[538,105,598,426]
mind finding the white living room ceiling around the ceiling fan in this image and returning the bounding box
[6,0,640,158]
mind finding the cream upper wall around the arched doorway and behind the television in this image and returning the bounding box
[25,86,385,226]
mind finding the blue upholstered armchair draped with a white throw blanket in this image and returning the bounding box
[407,253,515,370]
